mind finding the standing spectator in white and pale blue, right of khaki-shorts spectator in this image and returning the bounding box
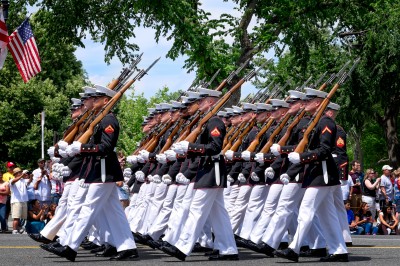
[32,158,51,206]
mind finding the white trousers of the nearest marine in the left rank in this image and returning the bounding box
[67,183,136,252]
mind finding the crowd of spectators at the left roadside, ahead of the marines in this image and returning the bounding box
[0,158,63,234]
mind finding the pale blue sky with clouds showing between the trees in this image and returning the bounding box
[75,0,264,98]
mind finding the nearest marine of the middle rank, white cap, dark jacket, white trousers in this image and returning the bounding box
[162,87,238,261]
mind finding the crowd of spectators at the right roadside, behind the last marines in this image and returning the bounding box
[341,161,400,235]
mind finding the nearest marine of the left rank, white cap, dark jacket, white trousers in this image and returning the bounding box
[50,85,138,261]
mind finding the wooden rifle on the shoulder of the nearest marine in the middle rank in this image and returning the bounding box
[185,63,266,142]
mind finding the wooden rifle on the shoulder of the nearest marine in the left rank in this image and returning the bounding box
[78,57,161,143]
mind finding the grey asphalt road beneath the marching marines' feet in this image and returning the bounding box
[0,234,400,266]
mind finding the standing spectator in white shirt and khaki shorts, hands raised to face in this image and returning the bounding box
[10,167,28,234]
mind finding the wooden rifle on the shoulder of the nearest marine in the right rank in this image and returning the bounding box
[295,58,360,153]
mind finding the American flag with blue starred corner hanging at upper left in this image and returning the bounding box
[7,18,42,83]
